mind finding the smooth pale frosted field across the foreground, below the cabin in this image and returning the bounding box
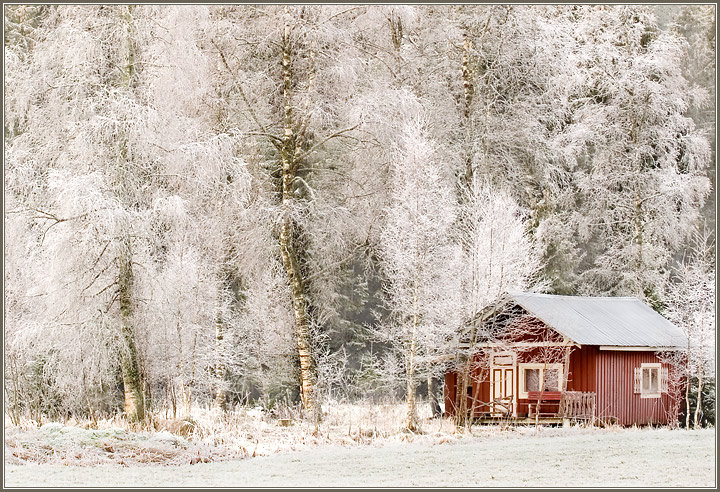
[5,428,716,487]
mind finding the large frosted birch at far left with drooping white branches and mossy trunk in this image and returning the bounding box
[8,7,165,420]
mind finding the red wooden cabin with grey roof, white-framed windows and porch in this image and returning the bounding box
[444,292,687,425]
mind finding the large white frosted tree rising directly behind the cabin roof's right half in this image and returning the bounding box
[566,6,709,302]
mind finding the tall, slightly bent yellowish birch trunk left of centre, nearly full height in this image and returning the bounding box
[279,26,319,416]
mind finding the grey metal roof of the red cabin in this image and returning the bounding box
[508,292,687,348]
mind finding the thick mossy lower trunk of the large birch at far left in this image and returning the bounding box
[118,236,145,422]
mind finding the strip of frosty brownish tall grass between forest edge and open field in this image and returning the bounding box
[5,403,619,466]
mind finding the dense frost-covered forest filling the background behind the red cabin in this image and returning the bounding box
[4,5,715,427]
